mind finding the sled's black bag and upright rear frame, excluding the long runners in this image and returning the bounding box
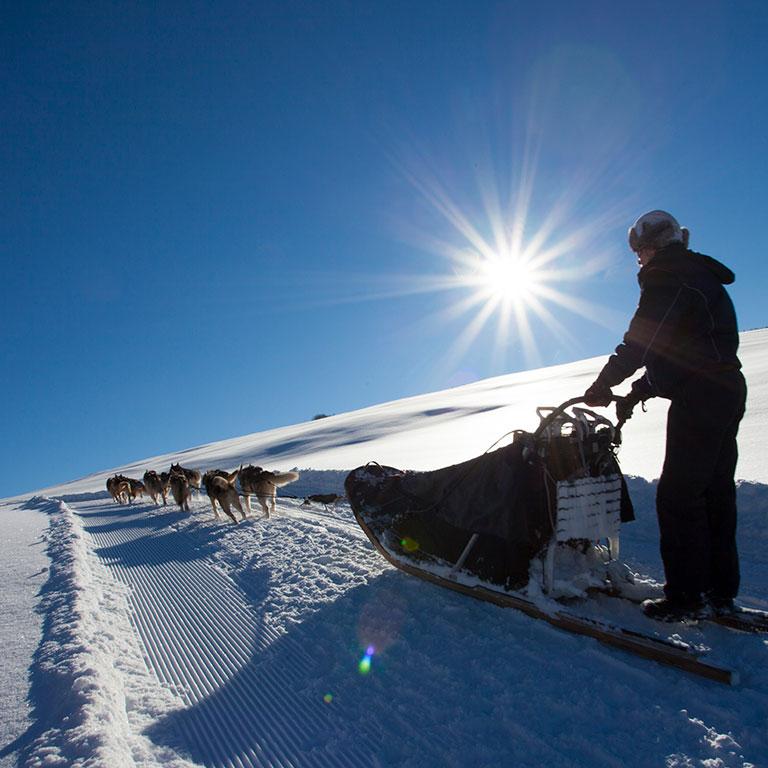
[345,399,634,594]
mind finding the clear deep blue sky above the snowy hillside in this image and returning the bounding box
[0,0,768,496]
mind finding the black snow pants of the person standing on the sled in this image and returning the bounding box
[656,370,747,601]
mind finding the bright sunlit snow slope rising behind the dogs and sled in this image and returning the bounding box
[22,329,768,495]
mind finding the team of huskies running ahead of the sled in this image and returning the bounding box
[107,464,300,523]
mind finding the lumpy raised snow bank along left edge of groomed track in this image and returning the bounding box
[24,496,195,768]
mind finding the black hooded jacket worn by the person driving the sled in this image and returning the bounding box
[597,243,741,399]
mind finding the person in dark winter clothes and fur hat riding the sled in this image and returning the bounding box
[584,211,747,621]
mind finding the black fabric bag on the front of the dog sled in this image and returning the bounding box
[345,433,634,589]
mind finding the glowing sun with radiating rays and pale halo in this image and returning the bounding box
[322,139,623,373]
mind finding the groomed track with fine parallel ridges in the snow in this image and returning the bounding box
[77,503,375,768]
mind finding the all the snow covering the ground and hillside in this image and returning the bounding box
[0,331,768,768]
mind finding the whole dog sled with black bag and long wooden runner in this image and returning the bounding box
[344,398,735,683]
